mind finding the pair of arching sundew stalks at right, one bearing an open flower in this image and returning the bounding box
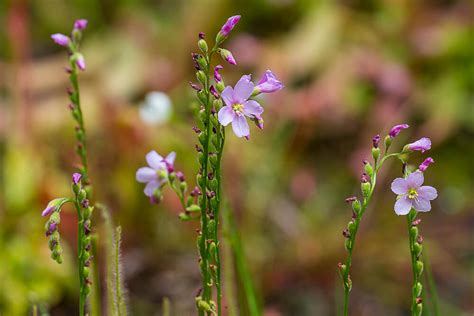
[338,124,437,316]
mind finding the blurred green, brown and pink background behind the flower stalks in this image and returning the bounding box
[0,0,474,316]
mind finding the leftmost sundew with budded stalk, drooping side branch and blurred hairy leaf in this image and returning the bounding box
[42,19,127,316]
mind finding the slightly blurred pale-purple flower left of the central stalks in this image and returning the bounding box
[136,150,176,198]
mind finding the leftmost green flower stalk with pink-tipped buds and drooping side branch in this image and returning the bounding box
[43,19,94,316]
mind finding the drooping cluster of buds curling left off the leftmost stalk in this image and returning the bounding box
[41,198,73,263]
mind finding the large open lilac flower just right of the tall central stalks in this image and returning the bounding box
[218,75,263,137]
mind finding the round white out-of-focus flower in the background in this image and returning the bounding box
[139,91,172,125]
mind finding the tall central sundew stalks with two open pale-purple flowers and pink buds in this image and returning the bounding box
[136,15,283,315]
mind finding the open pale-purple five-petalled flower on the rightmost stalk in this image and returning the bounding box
[392,171,438,215]
